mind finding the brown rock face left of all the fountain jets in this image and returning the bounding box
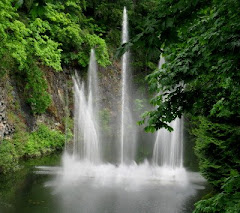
[0,67,73,143]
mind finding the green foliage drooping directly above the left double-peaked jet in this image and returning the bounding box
[40,1,109,67]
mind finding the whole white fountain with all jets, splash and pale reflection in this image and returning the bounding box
[31,8,208,213]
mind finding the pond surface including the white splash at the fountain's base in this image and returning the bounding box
[0,156,210,213]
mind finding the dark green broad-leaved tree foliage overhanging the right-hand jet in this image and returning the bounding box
[139,0,240,128]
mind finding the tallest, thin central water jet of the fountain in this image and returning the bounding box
[120,7,136,164]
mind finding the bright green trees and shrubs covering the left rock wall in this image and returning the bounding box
[0,0,110,174]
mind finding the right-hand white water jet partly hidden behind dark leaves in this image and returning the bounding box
[153,56,183,169]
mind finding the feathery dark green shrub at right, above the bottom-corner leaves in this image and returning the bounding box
[193,117,240,189]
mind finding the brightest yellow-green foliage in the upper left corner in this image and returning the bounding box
[0,1,61,70]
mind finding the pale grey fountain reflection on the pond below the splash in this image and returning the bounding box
[52,181,201,213]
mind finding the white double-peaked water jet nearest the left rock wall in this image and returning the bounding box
[73,50,100,163]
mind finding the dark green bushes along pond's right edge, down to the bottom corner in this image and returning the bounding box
[193,117,240,213]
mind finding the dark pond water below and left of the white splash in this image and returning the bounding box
[0,155,209,213]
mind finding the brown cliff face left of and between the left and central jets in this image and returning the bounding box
[0,62,135,141]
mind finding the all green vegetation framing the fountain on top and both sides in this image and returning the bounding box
[0,0,240,213]
